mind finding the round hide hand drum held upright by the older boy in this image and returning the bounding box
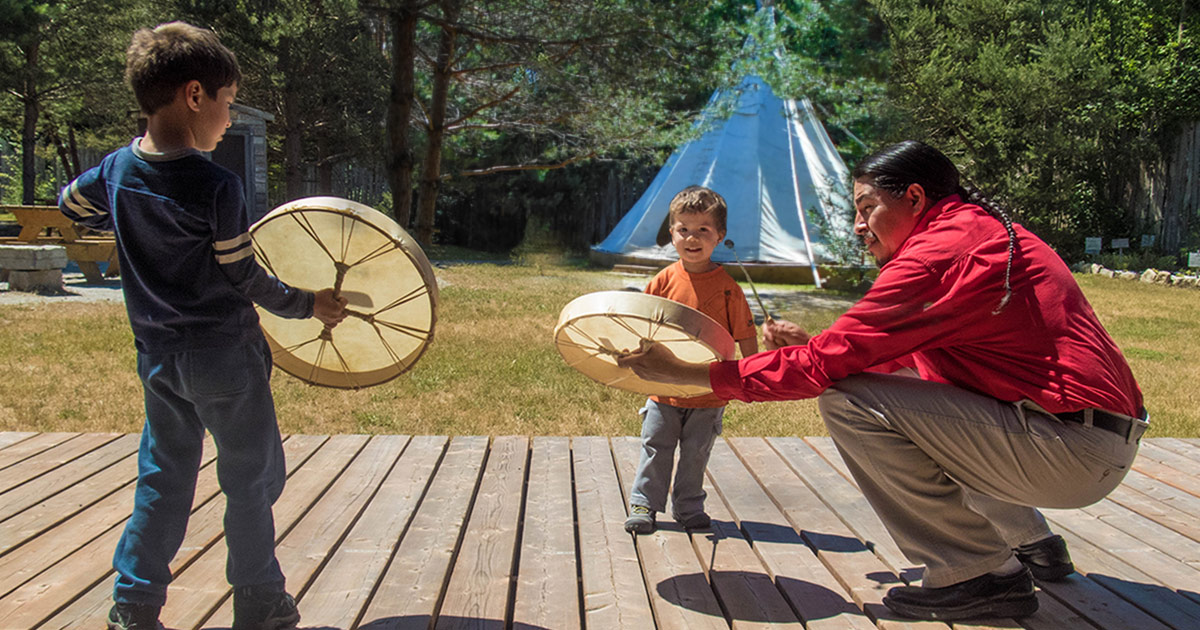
[250,197,438,389]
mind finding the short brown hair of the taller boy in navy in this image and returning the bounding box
[125,22,241,114]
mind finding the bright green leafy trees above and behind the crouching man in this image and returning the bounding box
[874,0,1200,257]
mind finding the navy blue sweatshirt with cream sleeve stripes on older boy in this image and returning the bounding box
[59,138,313,353]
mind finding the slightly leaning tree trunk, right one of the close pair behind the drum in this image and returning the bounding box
[416,0,461,246]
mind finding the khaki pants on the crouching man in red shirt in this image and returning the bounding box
[820,374,1138,588]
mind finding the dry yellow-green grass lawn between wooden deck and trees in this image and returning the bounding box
[0,262,1200,437]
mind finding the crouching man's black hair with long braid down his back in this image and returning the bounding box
[852,140,1016,313]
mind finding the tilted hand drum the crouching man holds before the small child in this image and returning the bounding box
[554,290,734,397]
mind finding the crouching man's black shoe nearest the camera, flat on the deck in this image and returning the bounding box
[883,569,1038,620]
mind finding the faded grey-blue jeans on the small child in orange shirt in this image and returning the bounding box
[629,400,725,521]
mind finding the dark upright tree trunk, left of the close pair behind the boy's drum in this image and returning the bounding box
[388,1,418,229]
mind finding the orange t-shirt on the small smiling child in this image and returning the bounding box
[646,262,758,409]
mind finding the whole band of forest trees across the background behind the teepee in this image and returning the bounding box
[0,0,1200,264]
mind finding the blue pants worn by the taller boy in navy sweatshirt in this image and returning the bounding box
[113,341,287,606]
